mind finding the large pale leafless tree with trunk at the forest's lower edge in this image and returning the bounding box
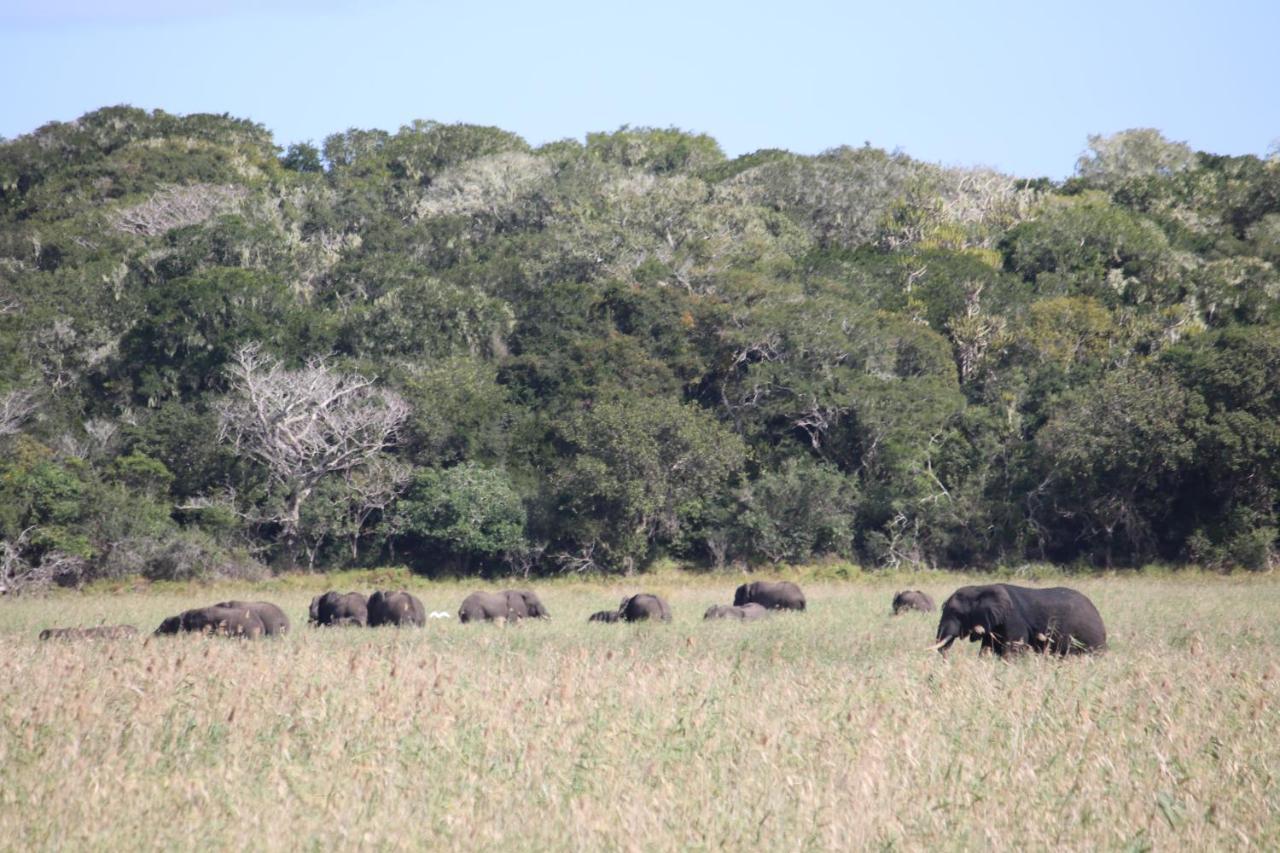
[219,343,410,562]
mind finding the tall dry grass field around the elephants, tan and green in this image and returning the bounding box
[0,575,1280,850]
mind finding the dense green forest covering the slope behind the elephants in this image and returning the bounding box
[0,106,1280,589]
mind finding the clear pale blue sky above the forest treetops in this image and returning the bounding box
[0,0,1280,178]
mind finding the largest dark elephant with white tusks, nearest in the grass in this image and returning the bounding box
[934,584,1107,657]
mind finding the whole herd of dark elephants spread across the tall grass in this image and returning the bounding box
[40,580,1107,657]
